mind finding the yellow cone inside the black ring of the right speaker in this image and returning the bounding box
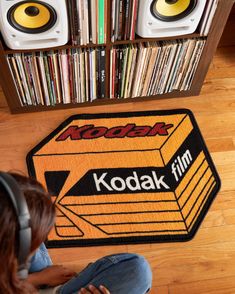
[155,0,191,17]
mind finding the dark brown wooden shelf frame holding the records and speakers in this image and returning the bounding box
[0,0,235,113]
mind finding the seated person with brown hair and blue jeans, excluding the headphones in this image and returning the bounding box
[0,173,152,294]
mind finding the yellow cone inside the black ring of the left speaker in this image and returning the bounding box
[13,2,51,29]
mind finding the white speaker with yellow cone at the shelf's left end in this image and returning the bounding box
[0,0,68,49]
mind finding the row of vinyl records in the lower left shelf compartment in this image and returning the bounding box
[7,47,106,106]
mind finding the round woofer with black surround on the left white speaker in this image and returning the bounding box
[7,1,57,34]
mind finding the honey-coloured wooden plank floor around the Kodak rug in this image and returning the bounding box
[0,47,235,294]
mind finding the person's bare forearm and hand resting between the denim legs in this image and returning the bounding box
[28,265,76,287]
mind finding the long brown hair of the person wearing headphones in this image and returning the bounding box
[0,173,55,294]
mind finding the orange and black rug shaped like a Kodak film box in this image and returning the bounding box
[27,109,220,247]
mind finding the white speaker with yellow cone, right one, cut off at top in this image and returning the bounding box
[136,0,206,38]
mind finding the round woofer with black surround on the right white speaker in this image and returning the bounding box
[151,0,197,22]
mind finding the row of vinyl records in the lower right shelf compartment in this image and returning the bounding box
[110,38,205,98]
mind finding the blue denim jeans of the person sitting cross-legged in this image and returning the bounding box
[29,244,152,294]
